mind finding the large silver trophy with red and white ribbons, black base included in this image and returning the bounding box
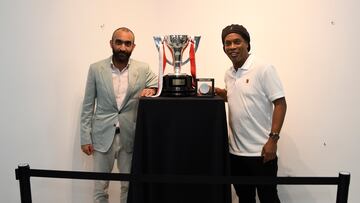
[154,35,200,96]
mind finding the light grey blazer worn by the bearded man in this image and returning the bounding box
[80,57,158,152]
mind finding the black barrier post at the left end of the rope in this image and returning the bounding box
[15,164,31,203]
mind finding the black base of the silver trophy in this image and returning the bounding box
[161,75,195,97]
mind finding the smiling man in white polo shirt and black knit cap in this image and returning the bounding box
[215,24,286,203]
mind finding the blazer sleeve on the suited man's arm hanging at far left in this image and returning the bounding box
[80,66,96,145]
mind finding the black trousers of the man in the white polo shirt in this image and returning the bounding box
[230,154,280,203]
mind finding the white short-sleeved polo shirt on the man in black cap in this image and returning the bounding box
[225,55,285,156]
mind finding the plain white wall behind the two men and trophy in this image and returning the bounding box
[0,0,360,203]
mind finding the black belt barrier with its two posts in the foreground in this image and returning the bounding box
[15,164,350,203]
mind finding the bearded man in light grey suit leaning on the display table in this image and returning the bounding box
[80,27,157,203]
